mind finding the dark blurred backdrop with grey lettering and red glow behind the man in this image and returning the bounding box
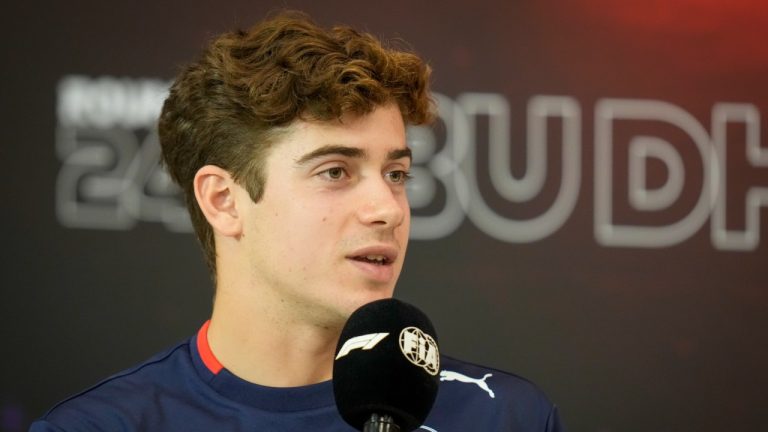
[0,0,768,432]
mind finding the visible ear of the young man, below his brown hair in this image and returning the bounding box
[193,165,242,237]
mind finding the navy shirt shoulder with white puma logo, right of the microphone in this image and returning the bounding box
[426,356,563,432]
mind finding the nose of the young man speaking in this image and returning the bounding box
[358,177,410,228]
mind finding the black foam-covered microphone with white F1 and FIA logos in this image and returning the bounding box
[333,299,440,432]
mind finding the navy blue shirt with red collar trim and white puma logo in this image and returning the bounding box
[30,323,564,432]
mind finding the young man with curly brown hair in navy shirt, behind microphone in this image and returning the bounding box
[32,13,560,432]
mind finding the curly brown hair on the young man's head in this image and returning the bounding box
[158,12,433,279]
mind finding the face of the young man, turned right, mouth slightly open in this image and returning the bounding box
[241,105,411,326]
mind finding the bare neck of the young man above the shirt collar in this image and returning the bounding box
[208,286,341,387]
